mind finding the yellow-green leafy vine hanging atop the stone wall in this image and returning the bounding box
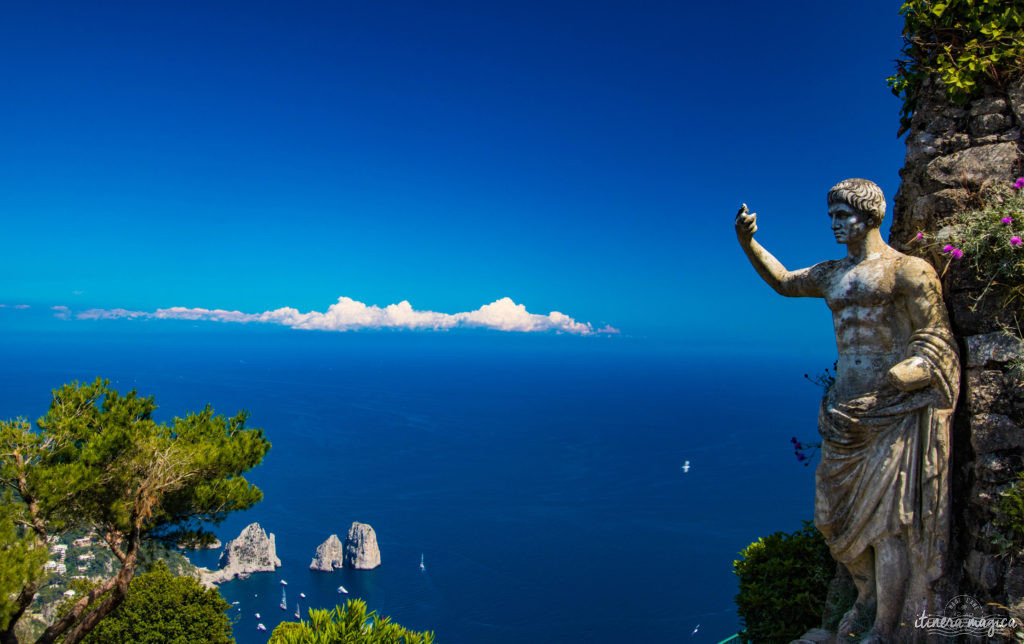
[887,0,1024,133]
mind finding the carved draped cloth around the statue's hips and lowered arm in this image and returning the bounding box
[814,328,959,581]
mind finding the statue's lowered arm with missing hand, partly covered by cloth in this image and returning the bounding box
[888,257,949,391]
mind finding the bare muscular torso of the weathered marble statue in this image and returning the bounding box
[822,249,911,398]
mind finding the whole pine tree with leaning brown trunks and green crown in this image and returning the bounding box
[0,379,270,644]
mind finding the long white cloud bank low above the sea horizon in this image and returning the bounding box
[74,297,618,336]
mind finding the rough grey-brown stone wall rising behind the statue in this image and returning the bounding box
[889,75,1024,606]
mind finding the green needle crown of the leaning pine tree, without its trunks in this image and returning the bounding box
[32,379,270,545]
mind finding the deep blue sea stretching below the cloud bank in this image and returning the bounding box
[0,321,819,644]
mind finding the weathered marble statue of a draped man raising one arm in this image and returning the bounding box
[735,179,959,642]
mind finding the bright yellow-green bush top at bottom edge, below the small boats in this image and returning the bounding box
[269,599,434,644]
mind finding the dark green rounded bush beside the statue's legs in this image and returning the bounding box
[732,521,836,644]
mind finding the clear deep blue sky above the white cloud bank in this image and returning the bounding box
[0,0,904,344]
